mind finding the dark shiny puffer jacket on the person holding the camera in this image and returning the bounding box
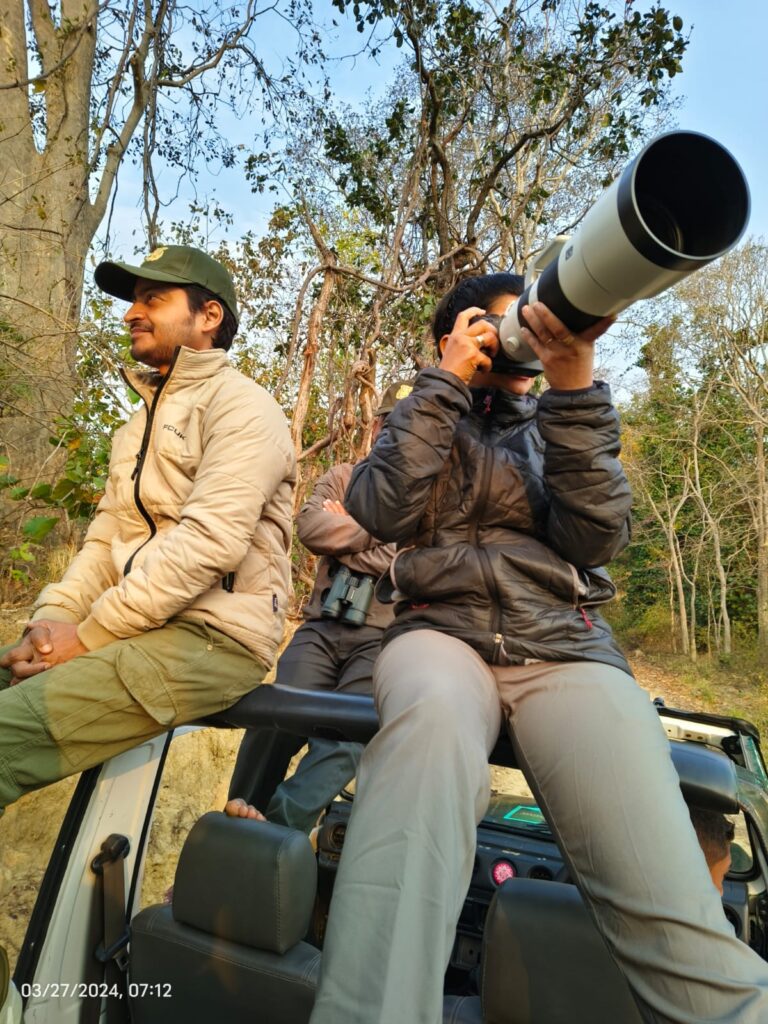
[345,368,632,672]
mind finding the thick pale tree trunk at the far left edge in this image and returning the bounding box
[0,0,100,479]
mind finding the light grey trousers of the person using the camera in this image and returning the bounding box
[311,630,768,1024]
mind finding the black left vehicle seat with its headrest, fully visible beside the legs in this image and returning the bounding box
[130,811,321,1024]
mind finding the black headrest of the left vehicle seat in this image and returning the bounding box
[173,811,317,953]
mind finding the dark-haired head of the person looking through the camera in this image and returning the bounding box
[432,273,536,394]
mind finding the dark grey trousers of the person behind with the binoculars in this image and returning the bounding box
[229,618,383,833]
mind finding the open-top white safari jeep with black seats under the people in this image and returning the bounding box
[0,686,768,1024]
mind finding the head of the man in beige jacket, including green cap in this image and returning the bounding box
[95,246,238,373]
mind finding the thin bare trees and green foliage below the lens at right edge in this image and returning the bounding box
[617,243,768,663]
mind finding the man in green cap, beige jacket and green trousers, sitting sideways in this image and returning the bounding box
[0,246,296,813]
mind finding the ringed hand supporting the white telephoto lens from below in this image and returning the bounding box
[520,302,615,391]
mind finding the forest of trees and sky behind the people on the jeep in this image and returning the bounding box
[0,0,768,966]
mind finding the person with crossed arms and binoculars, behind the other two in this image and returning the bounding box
[225,381,411,833]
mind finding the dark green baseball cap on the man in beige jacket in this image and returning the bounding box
[93,246,238,322]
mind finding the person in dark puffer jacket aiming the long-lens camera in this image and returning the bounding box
[310,273,768,1024]
